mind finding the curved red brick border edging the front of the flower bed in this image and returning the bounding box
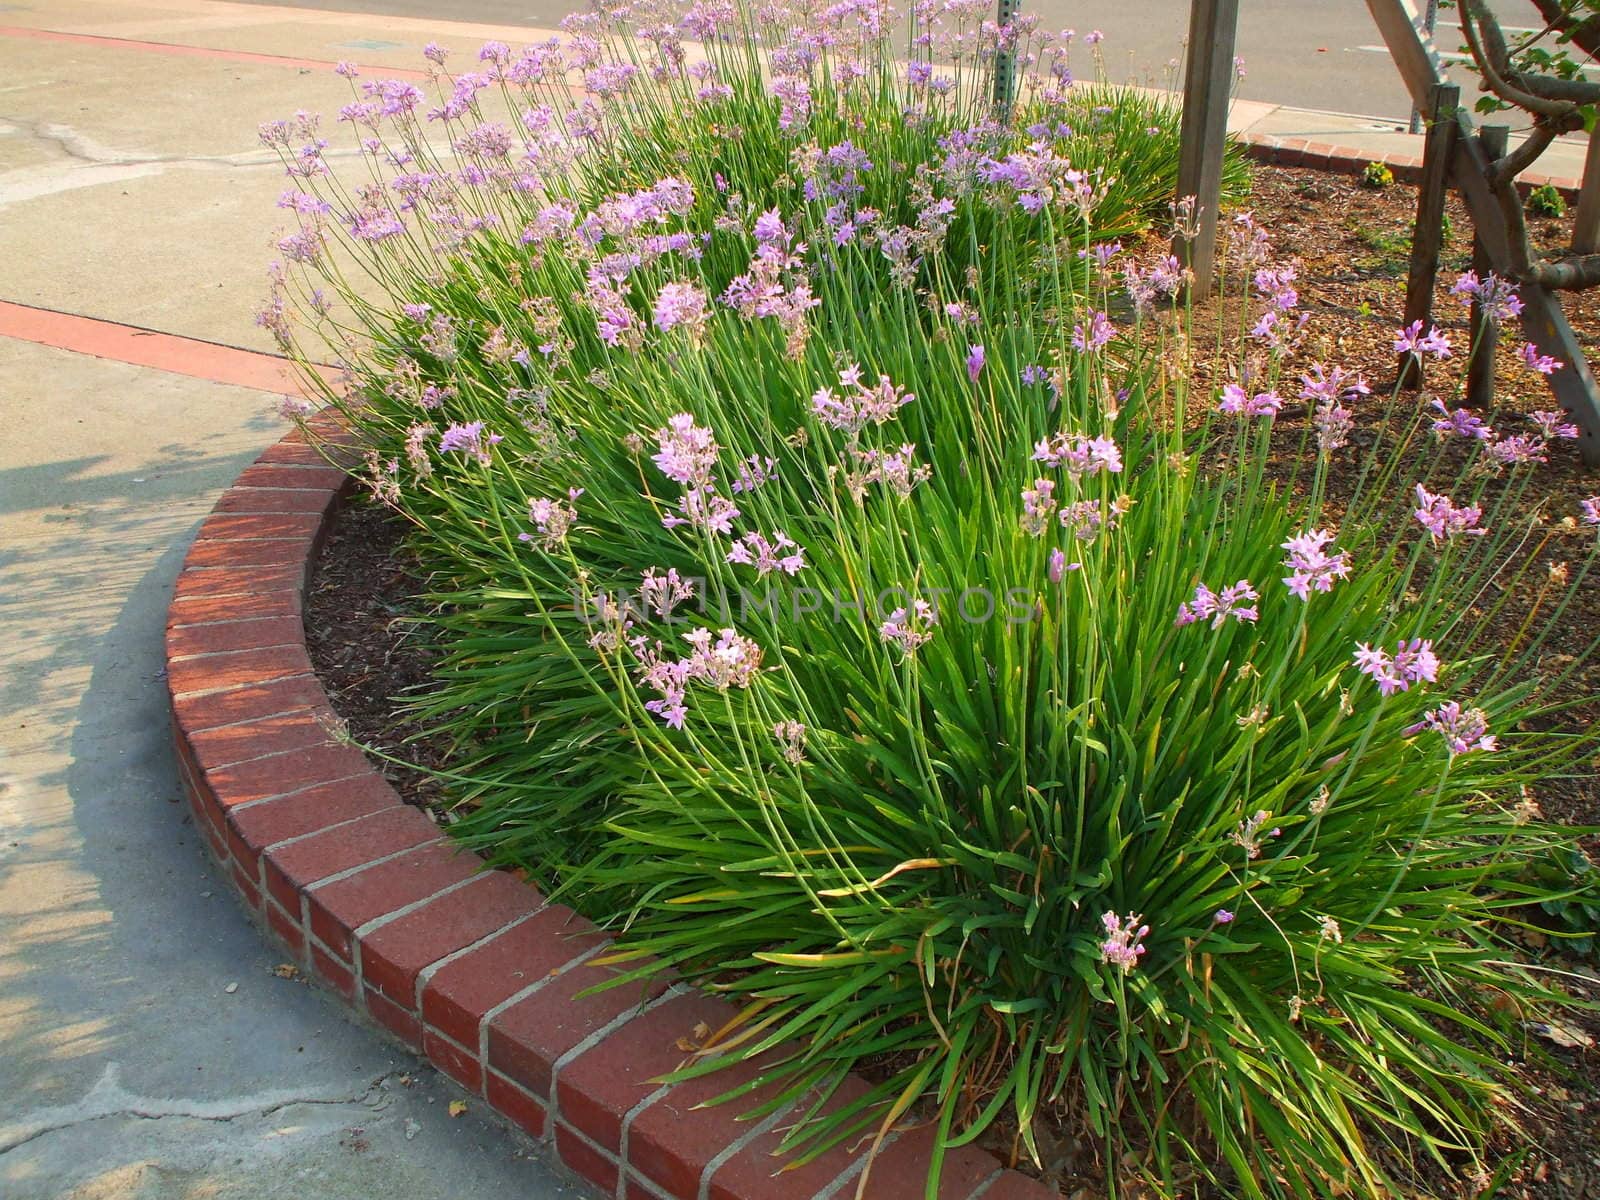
[166,418,1056,1200]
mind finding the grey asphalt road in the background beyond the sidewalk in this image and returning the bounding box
[232,0,1538,122]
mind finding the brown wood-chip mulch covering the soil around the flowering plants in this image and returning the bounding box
[306,168,1600,1200]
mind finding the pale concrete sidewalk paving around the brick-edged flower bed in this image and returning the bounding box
[0,0,1582,1200]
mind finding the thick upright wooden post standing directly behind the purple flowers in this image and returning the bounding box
[1173,0,1238,296]
